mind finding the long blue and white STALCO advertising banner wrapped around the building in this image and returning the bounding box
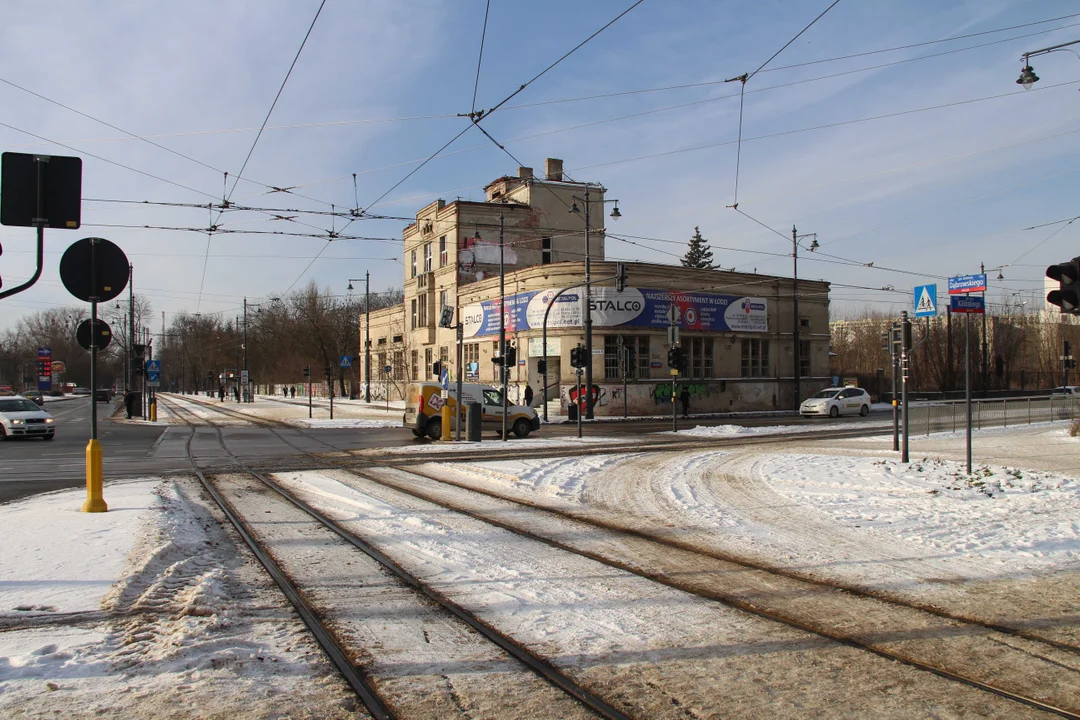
[461,287,769,338]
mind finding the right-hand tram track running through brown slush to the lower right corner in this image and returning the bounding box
[159,395,1080,718]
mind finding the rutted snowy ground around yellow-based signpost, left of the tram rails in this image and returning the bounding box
[0,478,356,718]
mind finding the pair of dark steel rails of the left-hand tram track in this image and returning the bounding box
[165,400,631,720]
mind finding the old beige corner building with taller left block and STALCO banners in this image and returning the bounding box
[360,159,828,416]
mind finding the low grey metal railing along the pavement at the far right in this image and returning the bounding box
[908,396,1080,435]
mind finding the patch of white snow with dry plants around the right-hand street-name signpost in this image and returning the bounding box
[755,454,1080,573]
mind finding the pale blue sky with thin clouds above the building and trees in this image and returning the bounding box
[0,0,1080,328]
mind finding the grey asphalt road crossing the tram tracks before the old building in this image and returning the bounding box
[0,397,885,503]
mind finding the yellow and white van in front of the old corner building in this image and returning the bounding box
[403,382,540,440]
